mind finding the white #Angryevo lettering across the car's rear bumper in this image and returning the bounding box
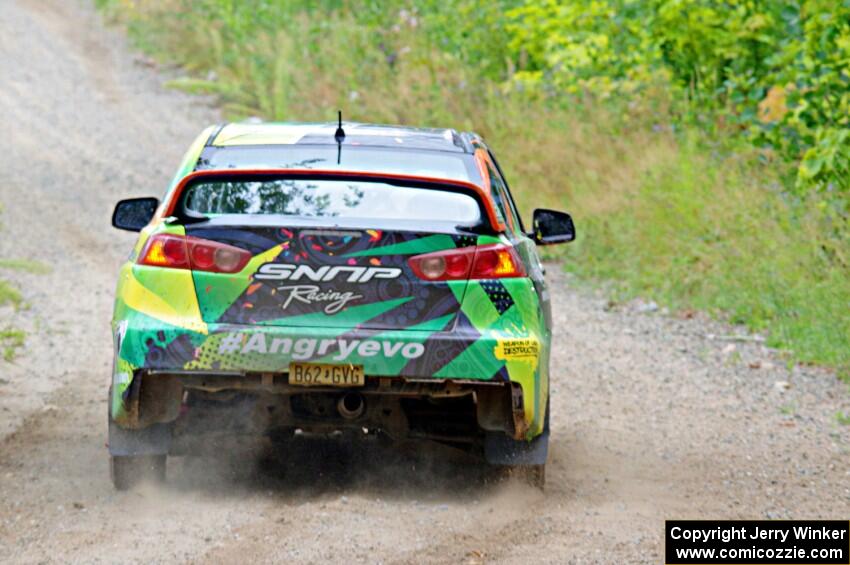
[218,332,425,361]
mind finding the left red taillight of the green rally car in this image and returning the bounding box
[139,233,251,273]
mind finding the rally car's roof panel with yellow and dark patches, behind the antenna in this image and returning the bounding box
[206,122,470,153]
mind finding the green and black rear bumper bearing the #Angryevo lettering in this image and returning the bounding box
[110,317,549,439]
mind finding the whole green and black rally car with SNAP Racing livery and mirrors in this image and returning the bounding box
[104,124,574,488]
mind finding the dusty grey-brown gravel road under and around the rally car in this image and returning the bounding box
[0,0,850,563]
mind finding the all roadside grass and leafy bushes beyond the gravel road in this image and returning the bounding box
[99,0,850,367]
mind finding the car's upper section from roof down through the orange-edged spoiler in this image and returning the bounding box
[162,121,505,231]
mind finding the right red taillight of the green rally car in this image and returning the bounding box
[408,243,525,281]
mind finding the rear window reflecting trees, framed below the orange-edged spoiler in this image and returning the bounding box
[183,179,481,225]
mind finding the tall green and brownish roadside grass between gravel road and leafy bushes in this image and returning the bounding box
[100,0,850,371]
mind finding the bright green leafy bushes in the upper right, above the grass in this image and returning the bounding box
[506,0,850,200]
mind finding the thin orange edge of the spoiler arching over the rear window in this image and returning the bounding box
[160,165,506,233]
